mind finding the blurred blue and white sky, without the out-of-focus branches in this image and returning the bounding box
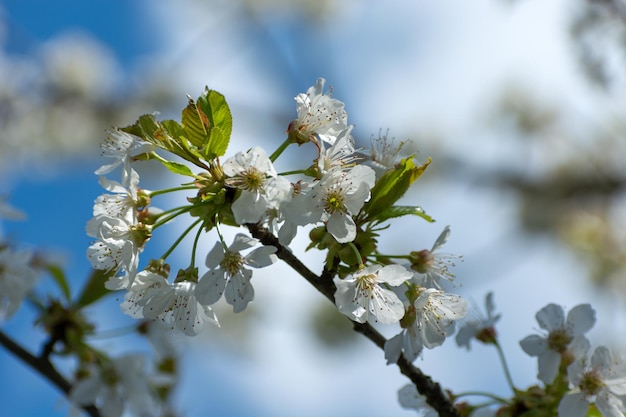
[0,0,610,417]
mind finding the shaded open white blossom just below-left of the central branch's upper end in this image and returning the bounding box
[196,233,277,313]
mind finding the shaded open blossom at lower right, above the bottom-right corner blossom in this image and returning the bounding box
[520,304,596,384]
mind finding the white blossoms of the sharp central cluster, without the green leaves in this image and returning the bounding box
[87,78,466,348]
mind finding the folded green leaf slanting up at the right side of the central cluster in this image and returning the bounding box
[362,155,431,221]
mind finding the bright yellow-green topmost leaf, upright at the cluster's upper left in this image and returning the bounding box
[197,87,233,160]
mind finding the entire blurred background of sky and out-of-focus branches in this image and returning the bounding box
[0,0,626,417]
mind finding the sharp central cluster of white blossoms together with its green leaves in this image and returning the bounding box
[86,78,467,412]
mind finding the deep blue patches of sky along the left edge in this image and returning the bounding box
[0,0,161,417]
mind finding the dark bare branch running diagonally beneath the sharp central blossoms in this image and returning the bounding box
[246,223,460,417]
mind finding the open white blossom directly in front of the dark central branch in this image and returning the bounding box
[335,265,411,323]
